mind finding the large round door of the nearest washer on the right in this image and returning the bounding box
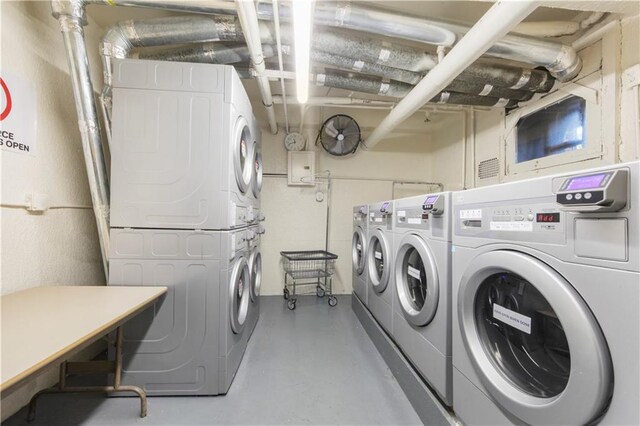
[457,250,612,424]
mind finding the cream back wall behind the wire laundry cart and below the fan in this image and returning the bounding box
[262,121,438,295]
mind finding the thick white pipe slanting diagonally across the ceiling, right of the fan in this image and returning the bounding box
[362,0,538,149]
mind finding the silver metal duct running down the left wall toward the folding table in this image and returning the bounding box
[52,2,109,280]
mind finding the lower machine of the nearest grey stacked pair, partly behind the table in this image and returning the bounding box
[109,229,251,395]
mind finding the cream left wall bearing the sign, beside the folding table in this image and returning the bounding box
[0,1,105,420]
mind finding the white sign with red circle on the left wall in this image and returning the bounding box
[0,71,37,155]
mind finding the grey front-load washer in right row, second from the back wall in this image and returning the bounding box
[366,201,394,333]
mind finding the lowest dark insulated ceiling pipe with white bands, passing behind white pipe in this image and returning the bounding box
[314,71,518,108]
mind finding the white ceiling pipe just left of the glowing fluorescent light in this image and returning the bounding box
[236,0,278,135]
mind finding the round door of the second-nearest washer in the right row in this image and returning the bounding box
[394,234,440,327]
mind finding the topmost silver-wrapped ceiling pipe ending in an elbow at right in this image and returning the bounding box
[260,3,582,82]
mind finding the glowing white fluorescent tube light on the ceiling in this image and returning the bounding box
[291,0,313,104]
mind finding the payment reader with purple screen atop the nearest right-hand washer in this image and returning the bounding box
[556,169,628,212]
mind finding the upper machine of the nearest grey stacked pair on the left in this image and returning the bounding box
[110,59,256,230]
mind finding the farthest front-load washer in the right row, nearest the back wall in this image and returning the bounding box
[351,205,369,306]
